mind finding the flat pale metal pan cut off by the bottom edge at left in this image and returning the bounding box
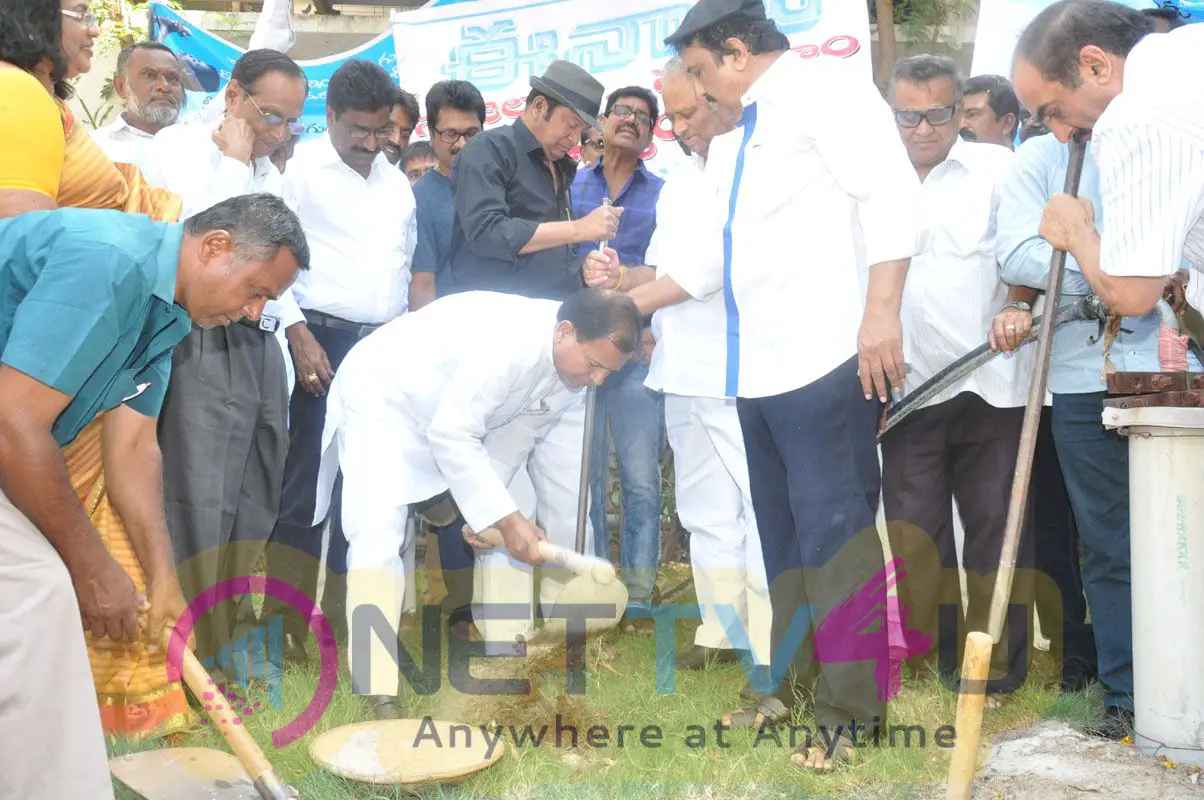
[108,747,259,800]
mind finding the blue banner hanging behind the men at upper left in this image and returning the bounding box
[147,2,397,139]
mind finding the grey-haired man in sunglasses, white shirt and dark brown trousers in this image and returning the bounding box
[883,54,1032,693]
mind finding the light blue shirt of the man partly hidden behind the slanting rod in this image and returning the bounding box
[996,134,1200,394]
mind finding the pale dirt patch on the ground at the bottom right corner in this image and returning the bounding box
[974,720,1204,800]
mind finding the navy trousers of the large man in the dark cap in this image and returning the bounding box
[737,359,887,731]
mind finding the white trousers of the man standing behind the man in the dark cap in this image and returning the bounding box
[665,394,772,664]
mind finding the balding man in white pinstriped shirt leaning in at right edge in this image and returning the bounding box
[1013,0,1204,317]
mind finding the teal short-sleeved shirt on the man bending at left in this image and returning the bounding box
[0,208,193,445]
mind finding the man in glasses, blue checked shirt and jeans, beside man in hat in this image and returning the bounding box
[572,86,665,634]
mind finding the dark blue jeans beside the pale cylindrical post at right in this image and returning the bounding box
[1054,392,1133,711]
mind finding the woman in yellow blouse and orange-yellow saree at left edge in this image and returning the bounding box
[0,0,195,740]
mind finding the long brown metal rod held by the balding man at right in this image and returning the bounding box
[987,137,1087,642]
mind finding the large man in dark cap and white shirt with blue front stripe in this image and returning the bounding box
[611,0,920,770]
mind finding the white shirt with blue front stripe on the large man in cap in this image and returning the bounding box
[656,52,921,398]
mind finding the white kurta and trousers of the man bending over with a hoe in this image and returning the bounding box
[314,292,591,694]
